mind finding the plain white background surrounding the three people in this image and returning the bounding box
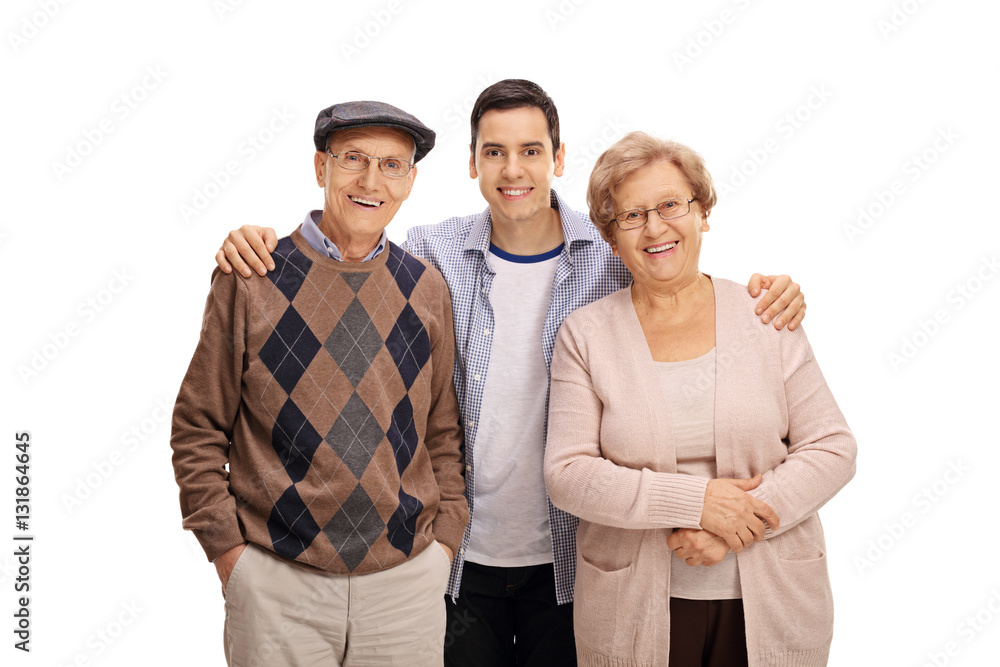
[0,0,1000,666]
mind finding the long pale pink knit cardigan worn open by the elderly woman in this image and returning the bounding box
[545,278,857,667]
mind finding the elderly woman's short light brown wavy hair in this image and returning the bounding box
[587,132,716,242]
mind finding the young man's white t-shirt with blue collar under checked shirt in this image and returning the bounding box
[465,245,562,567]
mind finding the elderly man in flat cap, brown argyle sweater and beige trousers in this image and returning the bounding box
[171,102,469,666]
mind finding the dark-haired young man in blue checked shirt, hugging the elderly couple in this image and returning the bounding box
[216,79,805,667]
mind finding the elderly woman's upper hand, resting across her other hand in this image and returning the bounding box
[701,475,778,553]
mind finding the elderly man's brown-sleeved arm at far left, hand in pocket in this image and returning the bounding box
[170,271,246,587]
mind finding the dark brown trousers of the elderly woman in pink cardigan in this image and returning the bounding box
[670,598,747,667]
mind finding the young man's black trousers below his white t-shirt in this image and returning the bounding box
[444,561,576,667]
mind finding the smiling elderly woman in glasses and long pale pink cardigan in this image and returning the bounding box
[545,132,856,667]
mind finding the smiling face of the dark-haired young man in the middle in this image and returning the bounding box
[469,107,565,224]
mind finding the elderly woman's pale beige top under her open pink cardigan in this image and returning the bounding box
[656,348,752,600]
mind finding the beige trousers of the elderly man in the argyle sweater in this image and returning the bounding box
[224,543,451,667]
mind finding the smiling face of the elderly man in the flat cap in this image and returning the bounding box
[315,127,417,247]
